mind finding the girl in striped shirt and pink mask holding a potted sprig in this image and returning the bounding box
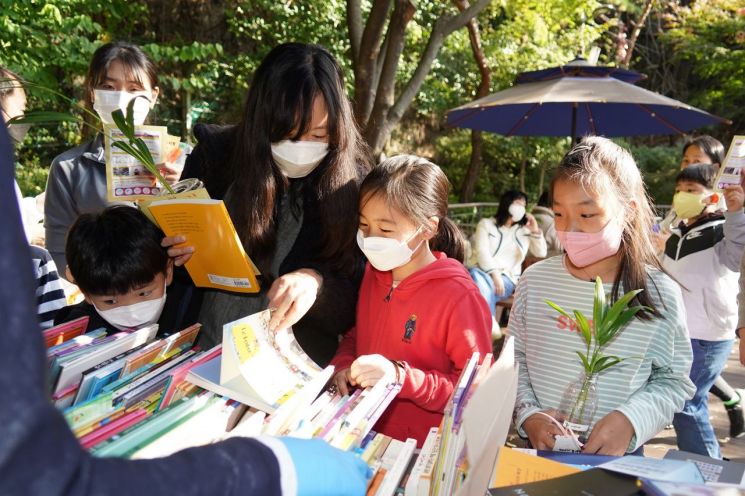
[508,137,695,455]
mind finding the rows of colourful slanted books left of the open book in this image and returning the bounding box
[44,317,219,455]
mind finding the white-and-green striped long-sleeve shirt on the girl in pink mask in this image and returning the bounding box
[508,256,695,451]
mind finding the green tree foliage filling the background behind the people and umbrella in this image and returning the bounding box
[0,0,732,207]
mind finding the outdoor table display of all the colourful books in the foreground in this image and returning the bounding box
[44,311,745,496]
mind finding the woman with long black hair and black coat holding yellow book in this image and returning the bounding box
[175,43,371,364]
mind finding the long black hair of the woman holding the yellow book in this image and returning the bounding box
[226,43,370,273]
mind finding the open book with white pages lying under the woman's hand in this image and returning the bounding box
[186,310,333,413]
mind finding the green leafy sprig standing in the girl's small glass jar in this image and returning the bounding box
[544,277,648,377]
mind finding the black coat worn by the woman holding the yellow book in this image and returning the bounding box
[181,124,364,366]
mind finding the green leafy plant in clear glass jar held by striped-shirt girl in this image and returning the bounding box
[545,277,647,442]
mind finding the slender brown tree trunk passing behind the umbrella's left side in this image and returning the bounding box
[453,0,491,203]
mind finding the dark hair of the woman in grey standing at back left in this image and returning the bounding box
[83,41,158,134]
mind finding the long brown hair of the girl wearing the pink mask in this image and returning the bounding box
[551,137,665,320]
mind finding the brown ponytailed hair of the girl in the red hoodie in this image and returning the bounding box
[360,155,465,262]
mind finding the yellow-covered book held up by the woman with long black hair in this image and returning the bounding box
[148,198,260,293]
